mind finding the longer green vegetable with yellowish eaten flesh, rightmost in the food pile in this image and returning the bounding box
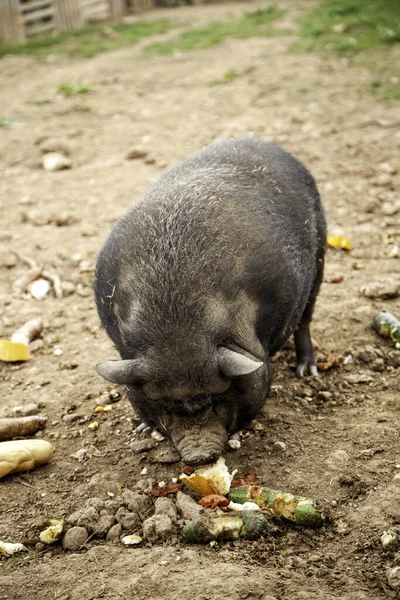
[228,485,324,527]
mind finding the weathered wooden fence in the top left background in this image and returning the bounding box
[0,0,156,44]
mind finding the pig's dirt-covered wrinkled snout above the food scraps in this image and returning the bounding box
[169,408,228,466]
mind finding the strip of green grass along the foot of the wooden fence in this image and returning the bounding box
[0,19,176,58]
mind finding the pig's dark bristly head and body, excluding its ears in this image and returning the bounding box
[95,139,326,462]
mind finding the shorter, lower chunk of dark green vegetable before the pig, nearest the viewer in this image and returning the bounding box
[183,510,270,544]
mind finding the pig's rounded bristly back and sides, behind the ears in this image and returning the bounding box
[95,139,325,357]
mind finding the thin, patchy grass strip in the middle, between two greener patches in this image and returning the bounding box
[144,4,287,56]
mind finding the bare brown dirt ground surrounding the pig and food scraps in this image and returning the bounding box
[0,1,400,600]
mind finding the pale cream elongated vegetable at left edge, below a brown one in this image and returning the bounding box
[0,440,53,479]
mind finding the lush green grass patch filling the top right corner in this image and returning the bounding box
[291,0,400,53]
